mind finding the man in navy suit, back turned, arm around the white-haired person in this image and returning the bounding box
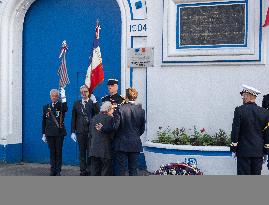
[96,88,145,176]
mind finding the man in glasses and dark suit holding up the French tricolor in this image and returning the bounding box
[71,85,99,176]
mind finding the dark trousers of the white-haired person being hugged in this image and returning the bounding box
[91,157,113,176]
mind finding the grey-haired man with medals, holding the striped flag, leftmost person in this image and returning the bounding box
[42,88,68,176]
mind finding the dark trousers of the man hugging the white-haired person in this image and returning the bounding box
[116,152,139,176]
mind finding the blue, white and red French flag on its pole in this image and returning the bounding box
[85,20,104,93]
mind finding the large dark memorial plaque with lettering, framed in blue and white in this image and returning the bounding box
[178,4,246,47]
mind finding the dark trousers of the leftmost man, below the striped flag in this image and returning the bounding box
[46,136,64,175]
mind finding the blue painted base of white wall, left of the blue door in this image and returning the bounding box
[0,144,22,163]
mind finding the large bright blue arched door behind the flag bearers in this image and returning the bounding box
[22,0,121,164]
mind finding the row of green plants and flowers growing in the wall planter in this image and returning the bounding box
[152,126,231,146]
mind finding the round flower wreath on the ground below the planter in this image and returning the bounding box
[154,162,203,175]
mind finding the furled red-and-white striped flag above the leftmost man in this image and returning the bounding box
[57,41,70,88]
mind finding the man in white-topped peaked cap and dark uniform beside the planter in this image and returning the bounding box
[231,85,269,175]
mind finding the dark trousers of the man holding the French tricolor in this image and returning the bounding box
[77,133,89,175]
